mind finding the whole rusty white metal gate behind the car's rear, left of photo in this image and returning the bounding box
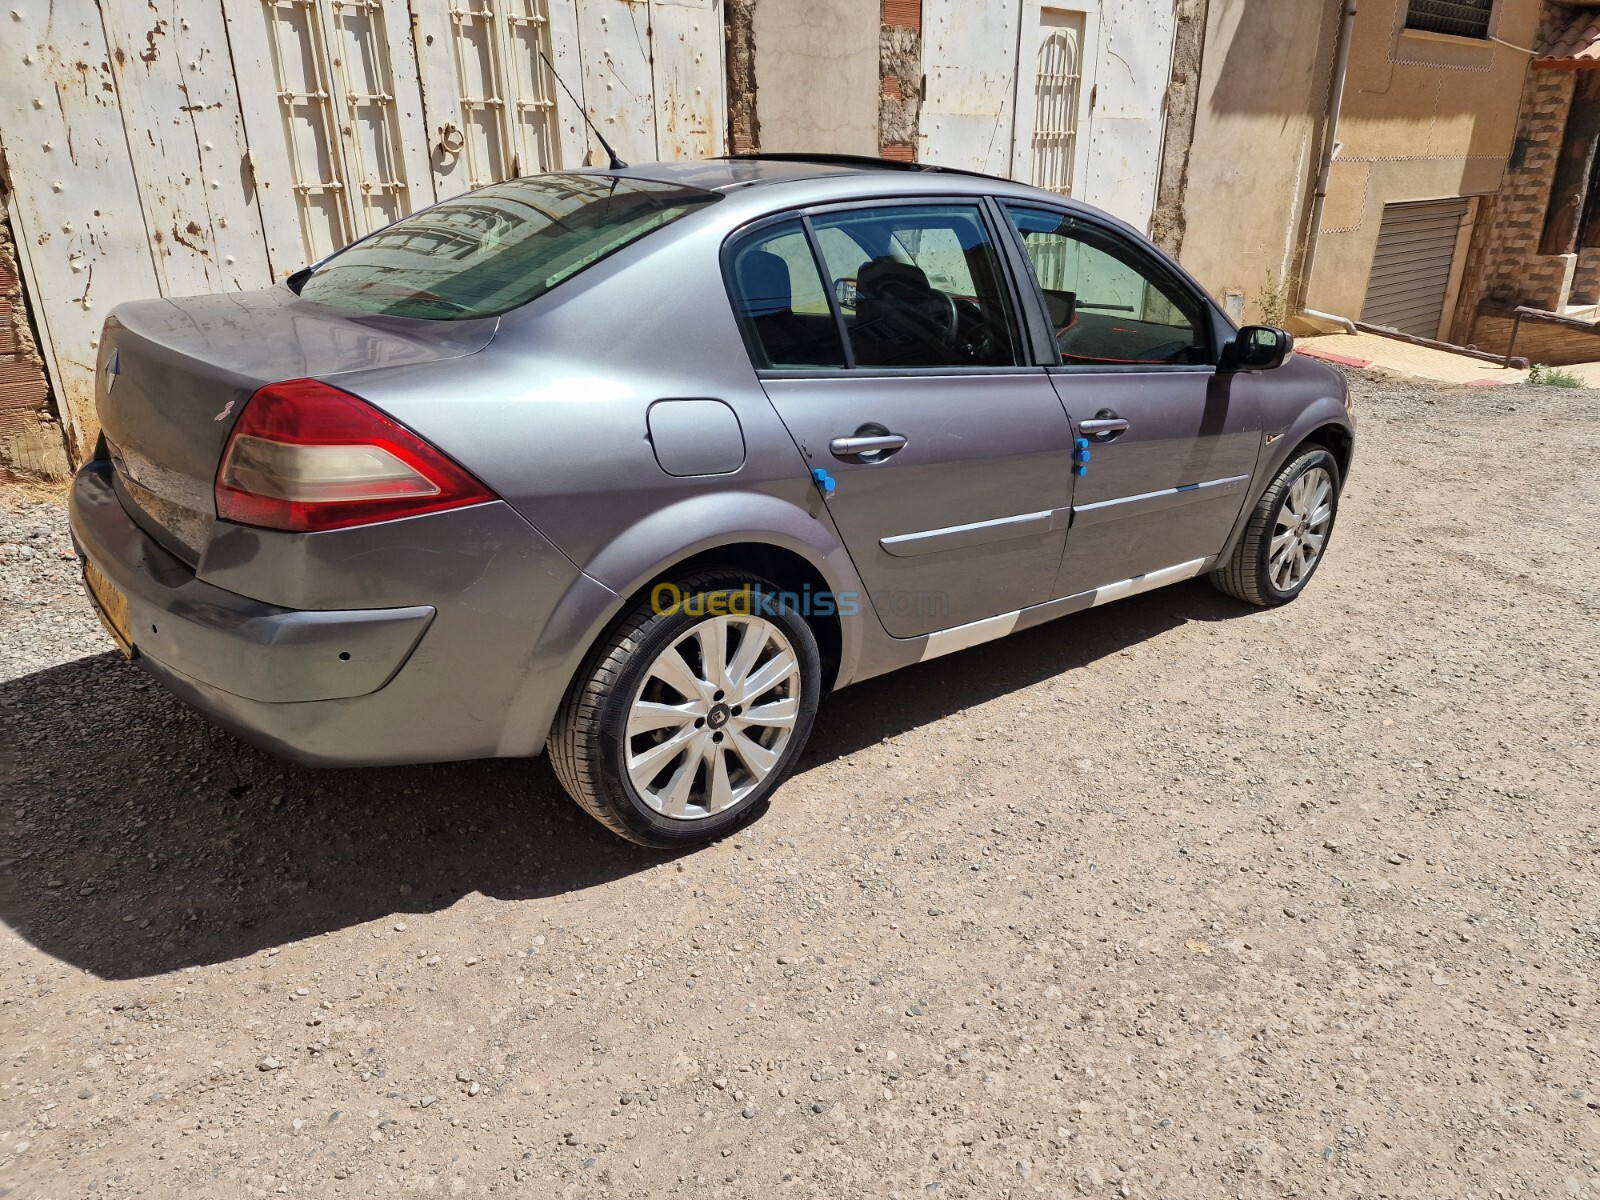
[0,0,726,456]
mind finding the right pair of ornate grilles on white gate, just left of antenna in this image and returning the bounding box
[450,0,562,187]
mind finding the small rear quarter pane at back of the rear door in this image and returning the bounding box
[730,221,845,370]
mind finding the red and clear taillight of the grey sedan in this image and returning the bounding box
[216,379,494,533]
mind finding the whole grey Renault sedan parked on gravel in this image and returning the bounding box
[72,155,1354,848]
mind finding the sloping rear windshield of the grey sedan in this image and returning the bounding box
[291,174,720,320]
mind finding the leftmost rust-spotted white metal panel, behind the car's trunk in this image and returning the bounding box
[0,0,160,454]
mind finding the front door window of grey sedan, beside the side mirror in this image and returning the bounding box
[1006,208,1211,366]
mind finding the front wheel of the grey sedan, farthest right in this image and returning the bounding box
[1211,446,1339,608]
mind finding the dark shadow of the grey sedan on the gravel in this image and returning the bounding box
[0,582,1253,979]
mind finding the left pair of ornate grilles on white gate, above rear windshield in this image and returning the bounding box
[264,0,411,261]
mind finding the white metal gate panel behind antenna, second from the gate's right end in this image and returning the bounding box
[578,0,656,165]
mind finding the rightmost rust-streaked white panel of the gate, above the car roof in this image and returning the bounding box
[650,0,728,160]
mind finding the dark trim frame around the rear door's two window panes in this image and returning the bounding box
[720,194,1059,379]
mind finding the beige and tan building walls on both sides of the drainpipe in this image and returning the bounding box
[1181,0,1541,326]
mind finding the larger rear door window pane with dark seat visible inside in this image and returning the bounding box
[814,205,1021,368]
